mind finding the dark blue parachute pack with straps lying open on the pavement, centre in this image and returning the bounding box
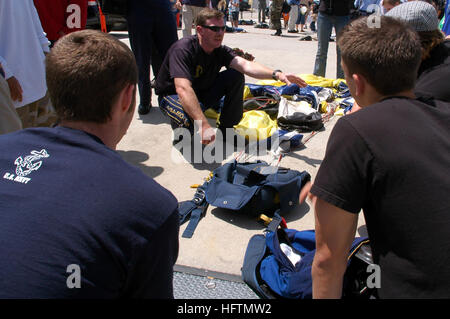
[178,160,311,238]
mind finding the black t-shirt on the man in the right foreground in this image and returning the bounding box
[311,98,450,298]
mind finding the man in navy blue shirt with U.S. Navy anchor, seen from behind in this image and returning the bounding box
[0,30,179,298]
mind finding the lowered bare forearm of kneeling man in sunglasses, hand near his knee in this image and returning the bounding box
[174,78,215,144]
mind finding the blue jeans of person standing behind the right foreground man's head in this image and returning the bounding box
[313,12,350,78]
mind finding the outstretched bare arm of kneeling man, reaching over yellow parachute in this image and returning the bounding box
[230,56,307,87]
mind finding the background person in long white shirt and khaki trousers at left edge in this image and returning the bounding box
[0,0,52,128]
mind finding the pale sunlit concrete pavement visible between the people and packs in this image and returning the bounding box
[112,12,365,284]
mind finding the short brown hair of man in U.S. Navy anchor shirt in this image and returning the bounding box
[46,30,138,123]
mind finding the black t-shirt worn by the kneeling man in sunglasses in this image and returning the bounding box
[155,35,236,95]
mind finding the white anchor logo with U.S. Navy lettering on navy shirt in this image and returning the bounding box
[3,149,50,184]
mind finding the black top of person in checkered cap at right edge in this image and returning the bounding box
[414,40,450,102]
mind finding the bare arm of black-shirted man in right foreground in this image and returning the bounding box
[311,197,358,299]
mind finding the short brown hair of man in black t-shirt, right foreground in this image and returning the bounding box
[338,16,421,95]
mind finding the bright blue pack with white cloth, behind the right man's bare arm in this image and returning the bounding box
[242,214,376,299]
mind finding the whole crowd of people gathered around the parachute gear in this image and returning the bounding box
[0,0,450,298]
